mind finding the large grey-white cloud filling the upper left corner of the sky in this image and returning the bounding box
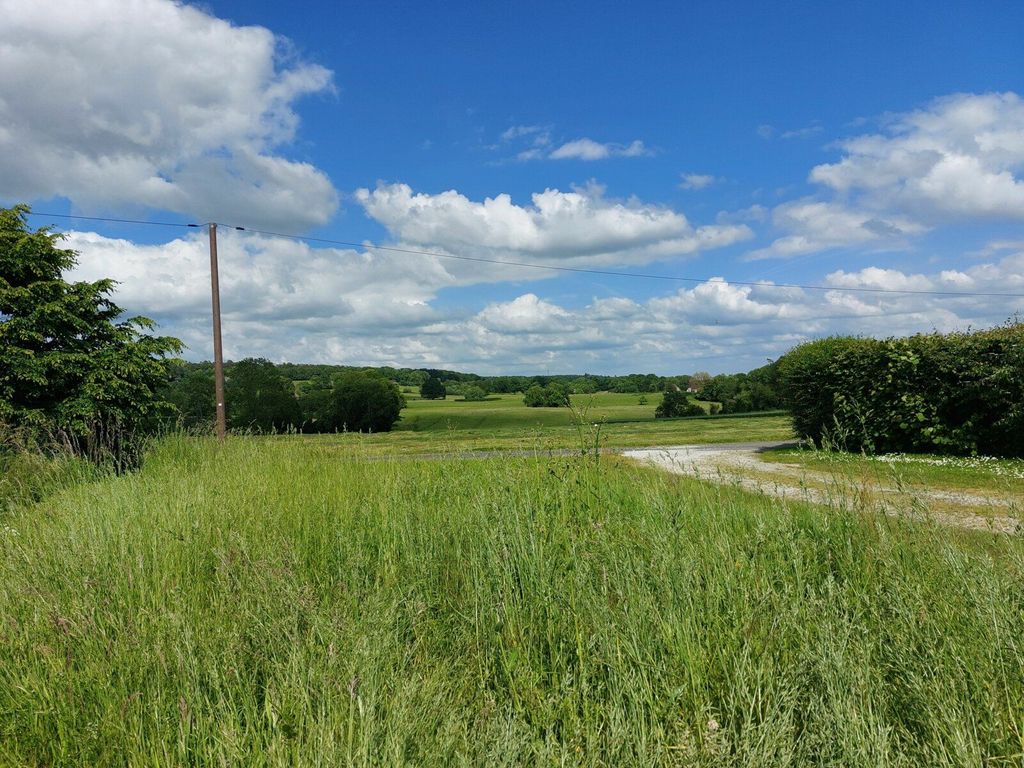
[0,0,337,227]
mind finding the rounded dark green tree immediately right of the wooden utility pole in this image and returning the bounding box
[224,357,302,432]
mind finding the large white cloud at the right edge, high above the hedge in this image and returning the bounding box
[752,93,1024,257]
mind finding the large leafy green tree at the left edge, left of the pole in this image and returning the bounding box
[0,205,181,466]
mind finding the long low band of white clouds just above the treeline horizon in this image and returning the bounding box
[61,230,1024,373]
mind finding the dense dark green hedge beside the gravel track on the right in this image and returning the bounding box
[778,323,1024,456]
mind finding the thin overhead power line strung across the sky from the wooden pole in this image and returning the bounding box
[22,212,1024,299]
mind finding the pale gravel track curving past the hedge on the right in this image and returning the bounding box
[622,442,1021,532]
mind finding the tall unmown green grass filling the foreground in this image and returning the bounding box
[0,437,1024,766]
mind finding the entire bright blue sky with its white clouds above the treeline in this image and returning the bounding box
[0,0,1024,374]
